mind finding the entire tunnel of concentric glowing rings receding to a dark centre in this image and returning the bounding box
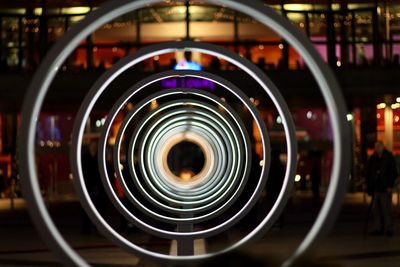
[19,0,350,266]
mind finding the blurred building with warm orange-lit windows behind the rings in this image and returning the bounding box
[0,0,400,201]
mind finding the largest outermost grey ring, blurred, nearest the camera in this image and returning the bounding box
[18,0,351,266]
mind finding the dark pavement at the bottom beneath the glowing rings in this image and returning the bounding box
[0,192,400,267]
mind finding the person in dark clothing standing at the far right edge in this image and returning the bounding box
[366,141,397,236]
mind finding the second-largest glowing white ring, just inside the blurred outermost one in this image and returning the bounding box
[71,42,297,241]
